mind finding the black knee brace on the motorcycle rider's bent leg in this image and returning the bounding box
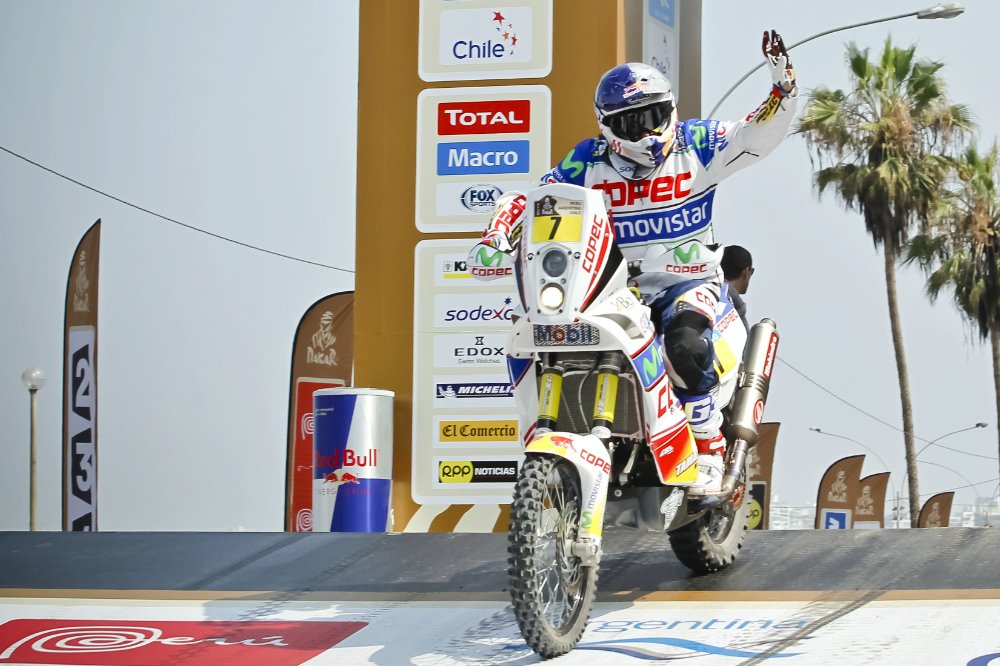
[663,310,719,392]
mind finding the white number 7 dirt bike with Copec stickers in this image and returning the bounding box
[508,184,778,658]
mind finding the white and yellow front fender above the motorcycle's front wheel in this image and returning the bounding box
[525,432,611,543]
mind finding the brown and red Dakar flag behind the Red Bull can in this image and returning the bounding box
[285,291,354,532]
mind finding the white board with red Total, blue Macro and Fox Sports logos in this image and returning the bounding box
[415,85,552,233]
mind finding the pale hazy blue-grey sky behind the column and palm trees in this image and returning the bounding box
[0,0,1000,530]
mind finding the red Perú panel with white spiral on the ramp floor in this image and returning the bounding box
[0,619,368,666]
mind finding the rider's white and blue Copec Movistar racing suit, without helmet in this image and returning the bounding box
[468,85,797,454]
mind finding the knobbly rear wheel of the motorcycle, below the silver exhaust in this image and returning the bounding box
[669,482,750,573]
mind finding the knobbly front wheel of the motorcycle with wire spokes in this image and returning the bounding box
[507,454,597,659]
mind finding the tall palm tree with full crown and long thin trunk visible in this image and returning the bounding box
[796,38,972,525]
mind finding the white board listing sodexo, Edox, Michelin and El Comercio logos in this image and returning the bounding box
[409,238,521,505]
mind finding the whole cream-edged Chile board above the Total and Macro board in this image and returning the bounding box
[417,0,552,81]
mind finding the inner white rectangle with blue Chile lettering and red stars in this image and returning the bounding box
[439,7,531,65]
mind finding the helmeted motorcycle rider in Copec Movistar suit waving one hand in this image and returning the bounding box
[468,30,798,494]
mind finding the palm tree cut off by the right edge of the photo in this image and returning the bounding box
[907,140,1000,472]
